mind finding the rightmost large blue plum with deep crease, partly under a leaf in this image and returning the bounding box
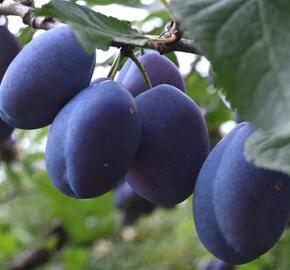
[193,123,290,264]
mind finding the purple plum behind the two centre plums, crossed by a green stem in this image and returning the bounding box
[117,51,185,97]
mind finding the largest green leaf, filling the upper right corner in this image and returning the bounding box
[171,0,290,132]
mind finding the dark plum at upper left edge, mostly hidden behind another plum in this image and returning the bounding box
[0,25,20,82]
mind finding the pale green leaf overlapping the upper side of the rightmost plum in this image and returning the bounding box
[245,130,290,175]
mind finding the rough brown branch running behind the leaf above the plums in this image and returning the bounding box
[0,2,202,55]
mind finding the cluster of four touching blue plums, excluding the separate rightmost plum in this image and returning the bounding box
[0,26,209,205]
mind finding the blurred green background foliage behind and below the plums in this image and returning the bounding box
[0,0,290,270]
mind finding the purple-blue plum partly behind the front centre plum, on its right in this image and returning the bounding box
[126,84,209,205]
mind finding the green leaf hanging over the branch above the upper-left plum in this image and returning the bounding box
[36,0,147,52]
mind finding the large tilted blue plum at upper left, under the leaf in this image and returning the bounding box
[0,26,95,129]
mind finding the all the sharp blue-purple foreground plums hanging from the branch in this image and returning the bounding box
[0,6,290,265]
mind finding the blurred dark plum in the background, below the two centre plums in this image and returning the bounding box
[114,181,156,225]
